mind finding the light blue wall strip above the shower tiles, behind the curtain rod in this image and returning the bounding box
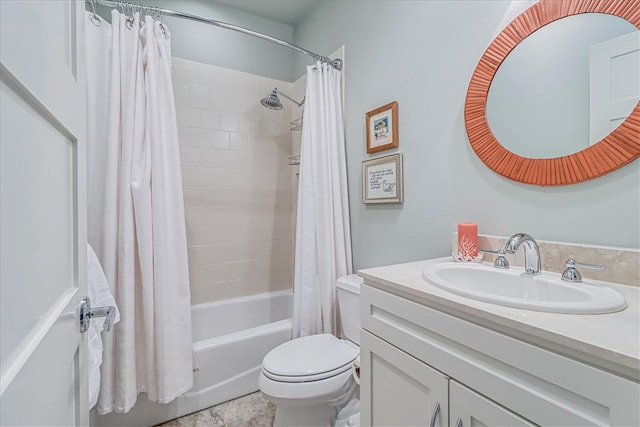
[94,0,294,82]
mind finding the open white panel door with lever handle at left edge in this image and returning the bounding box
[0,0,89,426]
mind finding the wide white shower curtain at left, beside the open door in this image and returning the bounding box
[86,10,193,414]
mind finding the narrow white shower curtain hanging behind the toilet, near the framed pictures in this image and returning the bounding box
[293,62,352,338]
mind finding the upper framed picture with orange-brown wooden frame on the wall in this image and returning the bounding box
[367,101,399,153]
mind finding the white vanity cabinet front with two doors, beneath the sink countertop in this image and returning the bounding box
[360,280,640,427]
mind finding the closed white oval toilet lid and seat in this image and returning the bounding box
[262,334,358,381]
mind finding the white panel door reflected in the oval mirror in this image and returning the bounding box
[589,31,640,145]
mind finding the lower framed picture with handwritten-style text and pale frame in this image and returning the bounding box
[362,154,402,203]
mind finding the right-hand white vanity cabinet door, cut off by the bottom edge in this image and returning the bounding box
[449,380,535,427]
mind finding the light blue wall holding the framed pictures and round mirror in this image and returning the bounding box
[294,0,640,269]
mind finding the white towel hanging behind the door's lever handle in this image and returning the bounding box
[87,244,120,409]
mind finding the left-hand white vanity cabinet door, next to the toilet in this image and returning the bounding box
[360,330,449,427]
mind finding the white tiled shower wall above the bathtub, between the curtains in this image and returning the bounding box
[173,59,299,304]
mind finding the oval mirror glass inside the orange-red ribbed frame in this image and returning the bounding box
[486,13,640,159]
